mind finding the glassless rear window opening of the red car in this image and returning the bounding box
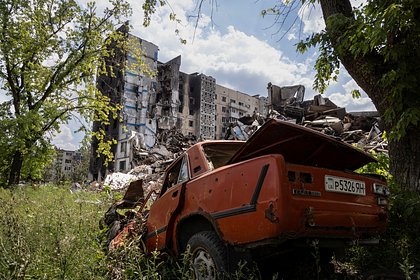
[203,141,244,170]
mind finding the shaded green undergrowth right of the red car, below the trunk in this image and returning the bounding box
[349,153,420,279]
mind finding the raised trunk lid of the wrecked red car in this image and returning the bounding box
[228,119,376,170]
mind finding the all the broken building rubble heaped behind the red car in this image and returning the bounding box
[105,86,387,199]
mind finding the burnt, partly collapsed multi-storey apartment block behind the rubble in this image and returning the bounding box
[90,29,267,181]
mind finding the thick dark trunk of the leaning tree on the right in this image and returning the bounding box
[319,0,420,192]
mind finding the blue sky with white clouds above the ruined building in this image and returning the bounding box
[0,0,375,150]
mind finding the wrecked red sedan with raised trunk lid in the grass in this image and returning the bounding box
[103,120,389,274]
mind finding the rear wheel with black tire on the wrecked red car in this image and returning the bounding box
[188,231,227,280]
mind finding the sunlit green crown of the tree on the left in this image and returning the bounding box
[0,0,130,184]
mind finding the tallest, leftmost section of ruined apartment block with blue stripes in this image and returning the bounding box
[90,25,160,179]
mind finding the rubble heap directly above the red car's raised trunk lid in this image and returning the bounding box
[225,95,388,155]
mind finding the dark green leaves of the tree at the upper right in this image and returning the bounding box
[297,0,420,140]
